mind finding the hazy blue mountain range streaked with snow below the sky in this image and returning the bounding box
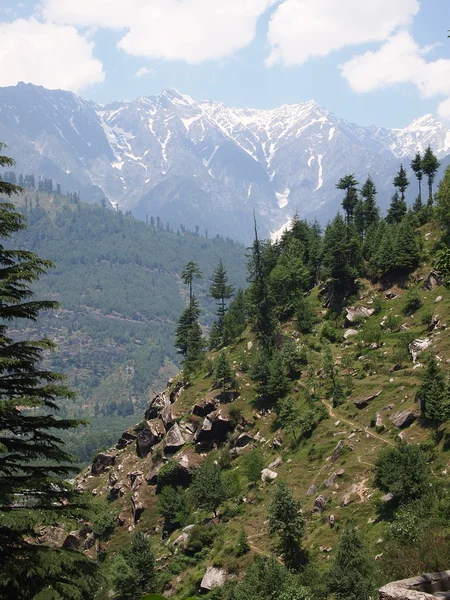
[0,83,450,241]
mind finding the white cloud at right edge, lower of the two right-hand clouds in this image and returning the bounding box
[341,31,450,117]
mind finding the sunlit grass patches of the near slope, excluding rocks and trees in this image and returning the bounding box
[78,226,450,600]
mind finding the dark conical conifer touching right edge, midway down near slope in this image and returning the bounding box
[418,356,450,433]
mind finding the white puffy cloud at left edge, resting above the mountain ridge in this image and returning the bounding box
[0,19,105,92]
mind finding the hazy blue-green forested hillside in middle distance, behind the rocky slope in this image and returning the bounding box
[2,191,246,460]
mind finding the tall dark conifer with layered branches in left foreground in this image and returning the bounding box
[0,144,96,600]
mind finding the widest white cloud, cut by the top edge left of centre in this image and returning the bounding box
[42,0,277,64]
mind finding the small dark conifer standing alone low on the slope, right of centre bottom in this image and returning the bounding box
[269,483,305,567]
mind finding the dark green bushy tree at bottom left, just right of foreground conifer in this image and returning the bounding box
[112,532,155,600]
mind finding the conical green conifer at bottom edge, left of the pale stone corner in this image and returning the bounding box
[328,523,376,600]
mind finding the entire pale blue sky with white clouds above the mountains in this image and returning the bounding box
[0,0,450,127]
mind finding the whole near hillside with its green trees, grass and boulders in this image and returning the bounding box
[66,158,450,600]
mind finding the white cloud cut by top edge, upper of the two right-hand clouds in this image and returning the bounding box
[267,0,420,65]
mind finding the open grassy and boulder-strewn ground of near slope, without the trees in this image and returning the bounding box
[77,226,450,600]
